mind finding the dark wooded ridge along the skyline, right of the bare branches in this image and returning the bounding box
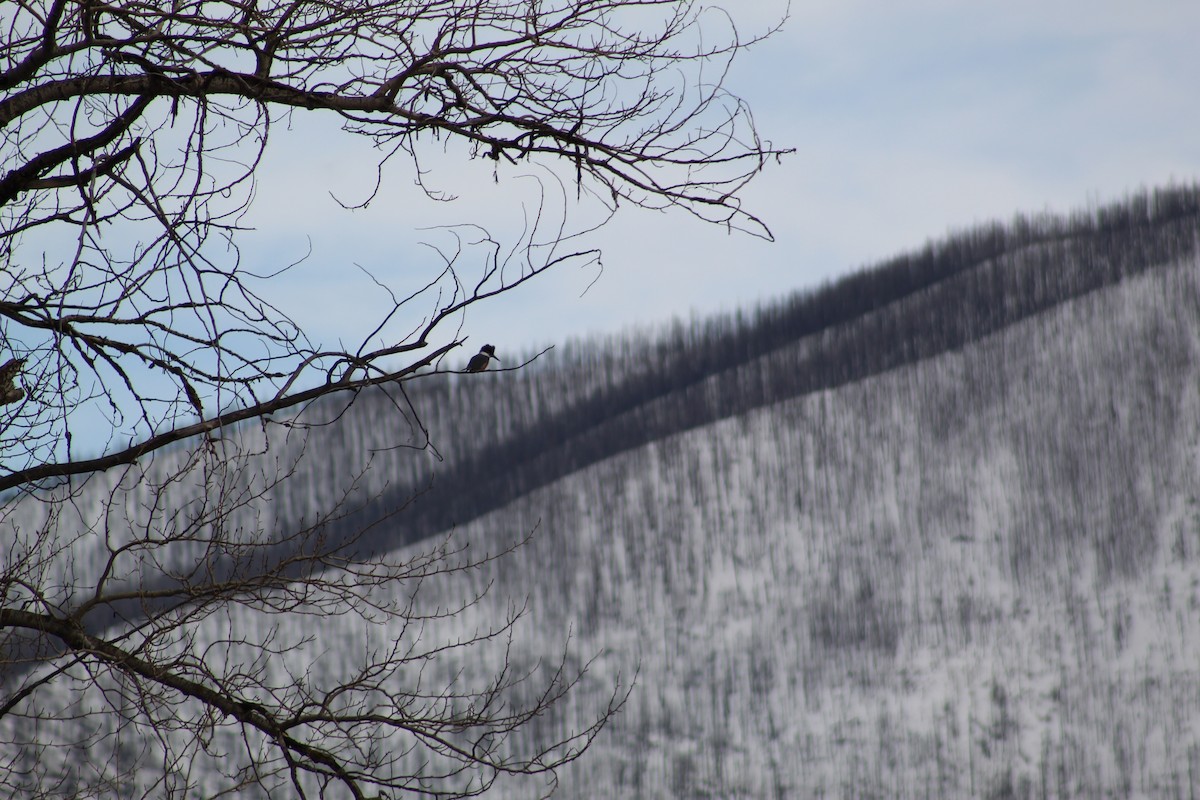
[346,186,1200,554]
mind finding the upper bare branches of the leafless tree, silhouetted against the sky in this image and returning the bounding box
[0,0,775,488]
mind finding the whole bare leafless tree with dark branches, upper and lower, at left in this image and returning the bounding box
[0,0,779,798]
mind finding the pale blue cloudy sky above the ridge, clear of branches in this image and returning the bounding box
[236,0,1200,357]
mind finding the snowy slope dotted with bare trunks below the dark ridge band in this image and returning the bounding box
[410,253,1200,798]
